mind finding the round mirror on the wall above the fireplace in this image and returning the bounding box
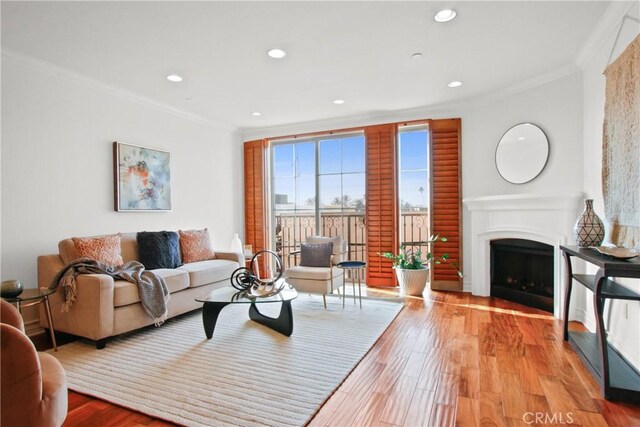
[496,123,549,184]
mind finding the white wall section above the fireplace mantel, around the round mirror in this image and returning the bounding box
[462,73,582,197]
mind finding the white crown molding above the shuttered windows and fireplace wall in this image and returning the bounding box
[240,63,581,141]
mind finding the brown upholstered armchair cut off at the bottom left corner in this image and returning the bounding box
[0,301,67,427]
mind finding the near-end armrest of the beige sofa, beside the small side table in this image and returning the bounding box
[38,255,114,340]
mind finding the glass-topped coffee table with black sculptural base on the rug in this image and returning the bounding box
[196,285,298,339]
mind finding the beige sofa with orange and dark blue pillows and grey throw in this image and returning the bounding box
[38,233,244,348]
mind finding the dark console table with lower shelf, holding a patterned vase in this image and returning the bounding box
[560,246,640,404]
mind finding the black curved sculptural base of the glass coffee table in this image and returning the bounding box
[202,301,293,339]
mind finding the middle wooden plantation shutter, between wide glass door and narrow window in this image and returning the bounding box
[365,124,398,286]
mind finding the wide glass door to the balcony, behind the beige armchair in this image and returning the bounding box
[271,133,366,265]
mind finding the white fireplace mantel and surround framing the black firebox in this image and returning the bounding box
[463,192,584,318]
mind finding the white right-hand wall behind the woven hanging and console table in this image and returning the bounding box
[577,2,640,369]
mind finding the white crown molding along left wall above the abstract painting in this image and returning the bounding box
[2,48,238,132]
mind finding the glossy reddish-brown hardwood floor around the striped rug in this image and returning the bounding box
[42,288,640,427]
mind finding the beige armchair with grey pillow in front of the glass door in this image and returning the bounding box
[285,236,347,309]
